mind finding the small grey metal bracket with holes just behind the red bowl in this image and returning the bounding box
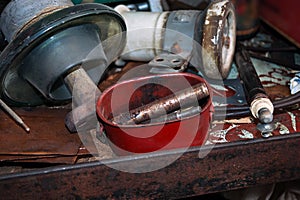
[149,54,187,74]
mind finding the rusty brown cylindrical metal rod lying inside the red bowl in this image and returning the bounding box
[112,83,209,125]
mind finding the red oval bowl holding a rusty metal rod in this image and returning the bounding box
[96,73,213,155]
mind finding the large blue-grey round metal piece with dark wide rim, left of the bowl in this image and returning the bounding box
[0,0,126,106]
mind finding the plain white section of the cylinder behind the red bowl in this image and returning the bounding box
[115,6,169,62]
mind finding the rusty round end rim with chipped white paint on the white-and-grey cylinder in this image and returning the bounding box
[202,1,236,79]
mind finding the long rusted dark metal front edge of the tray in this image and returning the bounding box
[0,134,300,199]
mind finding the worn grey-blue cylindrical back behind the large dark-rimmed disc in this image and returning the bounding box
[0,0,74,42]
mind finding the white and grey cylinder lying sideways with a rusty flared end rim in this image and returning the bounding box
[115,0,236,79]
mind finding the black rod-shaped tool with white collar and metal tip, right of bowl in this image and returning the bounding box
[235,44,274,124]
